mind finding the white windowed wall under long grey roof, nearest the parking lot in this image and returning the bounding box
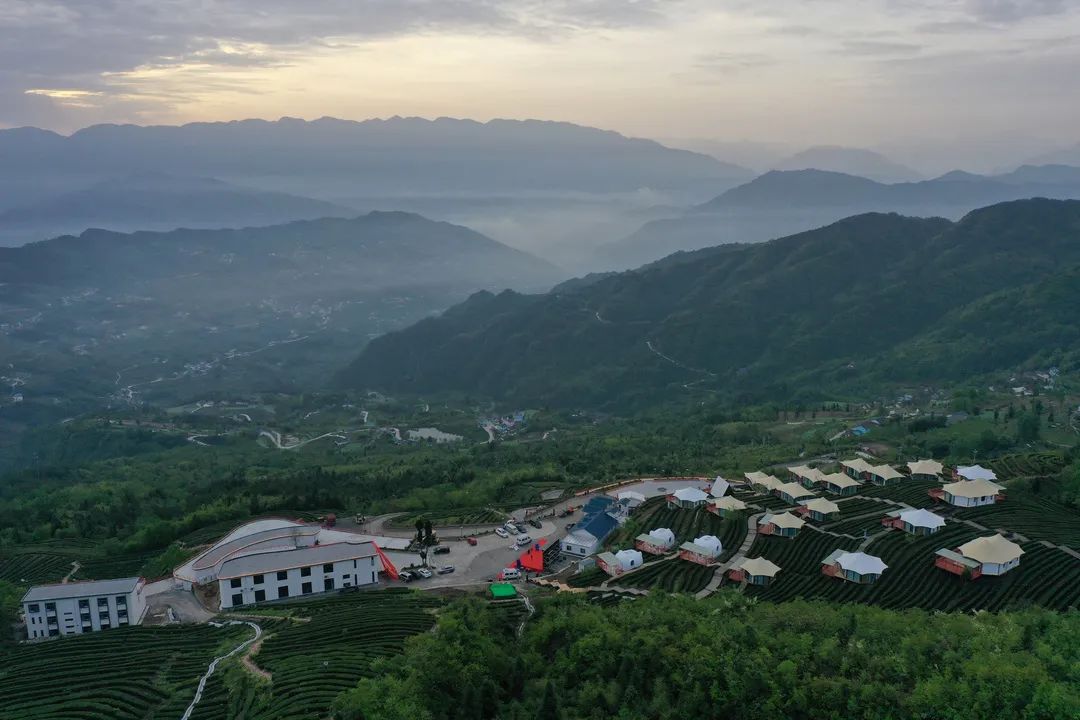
[217,555,382,610]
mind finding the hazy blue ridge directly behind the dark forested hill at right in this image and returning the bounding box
[591,165,1080,268]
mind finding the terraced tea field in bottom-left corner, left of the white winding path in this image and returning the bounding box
[0,625,252,720]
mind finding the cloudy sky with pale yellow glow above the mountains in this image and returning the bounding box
[0,0,1080,170]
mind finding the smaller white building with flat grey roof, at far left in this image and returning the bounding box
[23,578,146,640]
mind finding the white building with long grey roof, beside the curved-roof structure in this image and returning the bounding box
[217,541,382,610]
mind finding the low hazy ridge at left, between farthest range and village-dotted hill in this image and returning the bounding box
[0,172,356,246]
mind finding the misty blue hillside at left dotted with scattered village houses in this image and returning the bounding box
[0,213,565,416]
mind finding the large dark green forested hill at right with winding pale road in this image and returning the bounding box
[342,200,1080,404]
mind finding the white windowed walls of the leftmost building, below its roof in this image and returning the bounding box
[23,582,146,640]
